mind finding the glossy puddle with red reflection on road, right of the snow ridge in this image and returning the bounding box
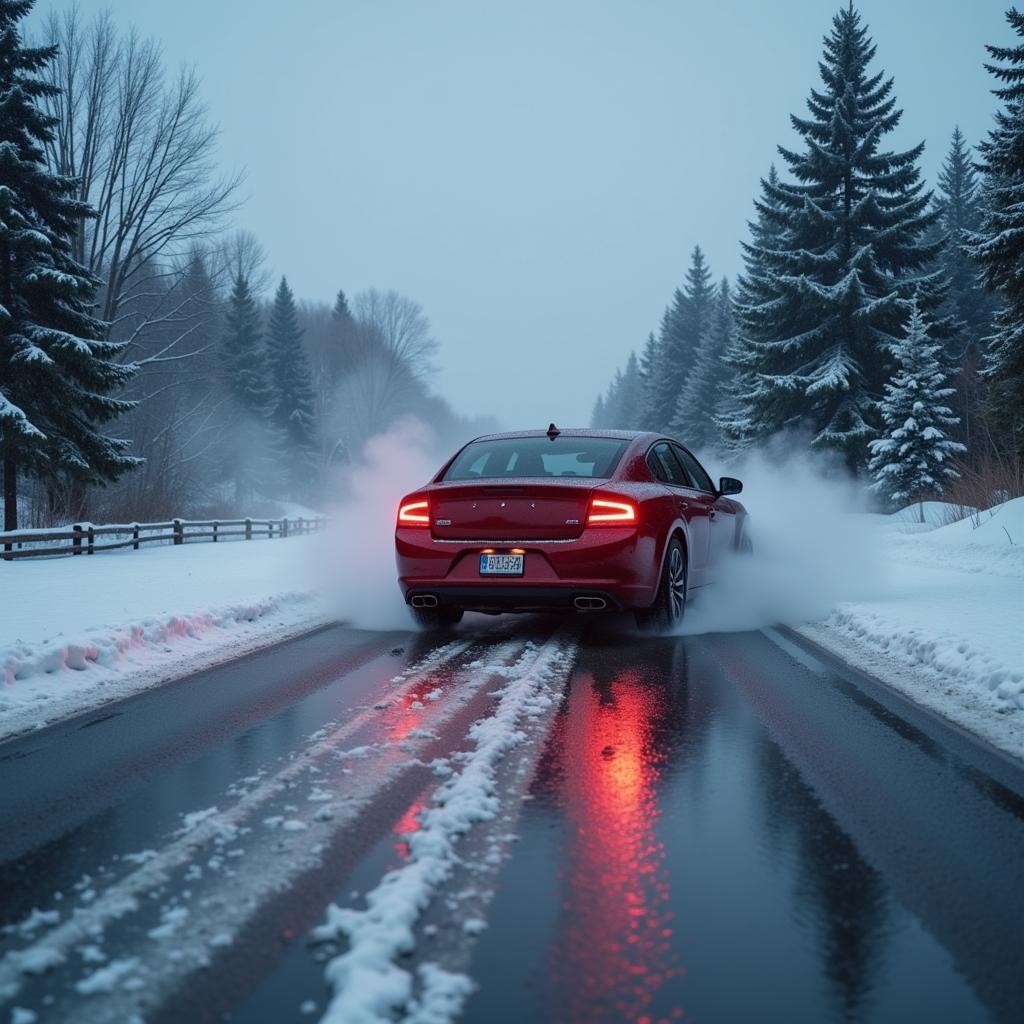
[464,635,1024,1024]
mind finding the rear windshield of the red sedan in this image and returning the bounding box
[444,437,626,480]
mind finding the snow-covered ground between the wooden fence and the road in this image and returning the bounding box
[0,535,330,738]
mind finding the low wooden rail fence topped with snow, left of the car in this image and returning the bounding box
[0,516,328,561]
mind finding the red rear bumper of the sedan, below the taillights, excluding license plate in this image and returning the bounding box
[395,527,659,611]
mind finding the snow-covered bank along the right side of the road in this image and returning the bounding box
[801,498,1024,758]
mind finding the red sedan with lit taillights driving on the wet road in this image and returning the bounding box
[395,424,749,629]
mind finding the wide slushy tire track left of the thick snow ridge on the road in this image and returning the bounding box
[0,637,524,1024]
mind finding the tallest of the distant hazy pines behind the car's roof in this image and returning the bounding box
[645,246,715,430]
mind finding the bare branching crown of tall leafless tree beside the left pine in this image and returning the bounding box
[38,8,241,335]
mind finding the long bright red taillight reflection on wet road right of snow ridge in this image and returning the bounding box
[552,673,683,1024]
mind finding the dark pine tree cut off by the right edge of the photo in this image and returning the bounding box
[968,7,1024,456]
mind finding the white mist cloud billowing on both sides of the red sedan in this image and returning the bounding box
[310,418,888,635]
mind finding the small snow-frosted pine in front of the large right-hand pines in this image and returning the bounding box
[868,300,967,521]
